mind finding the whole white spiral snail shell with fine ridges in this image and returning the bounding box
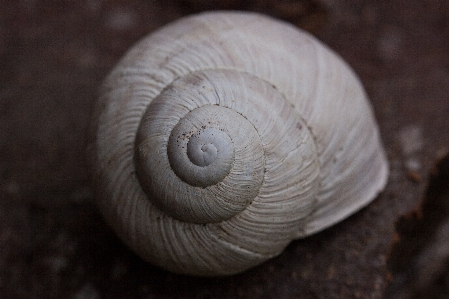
[89,12,388,275]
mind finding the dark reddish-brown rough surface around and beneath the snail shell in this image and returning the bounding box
[0,0,449,299]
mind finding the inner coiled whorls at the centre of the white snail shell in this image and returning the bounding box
[135,69,319,229]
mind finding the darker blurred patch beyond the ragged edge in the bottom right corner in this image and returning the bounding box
[385,156,449,299]
